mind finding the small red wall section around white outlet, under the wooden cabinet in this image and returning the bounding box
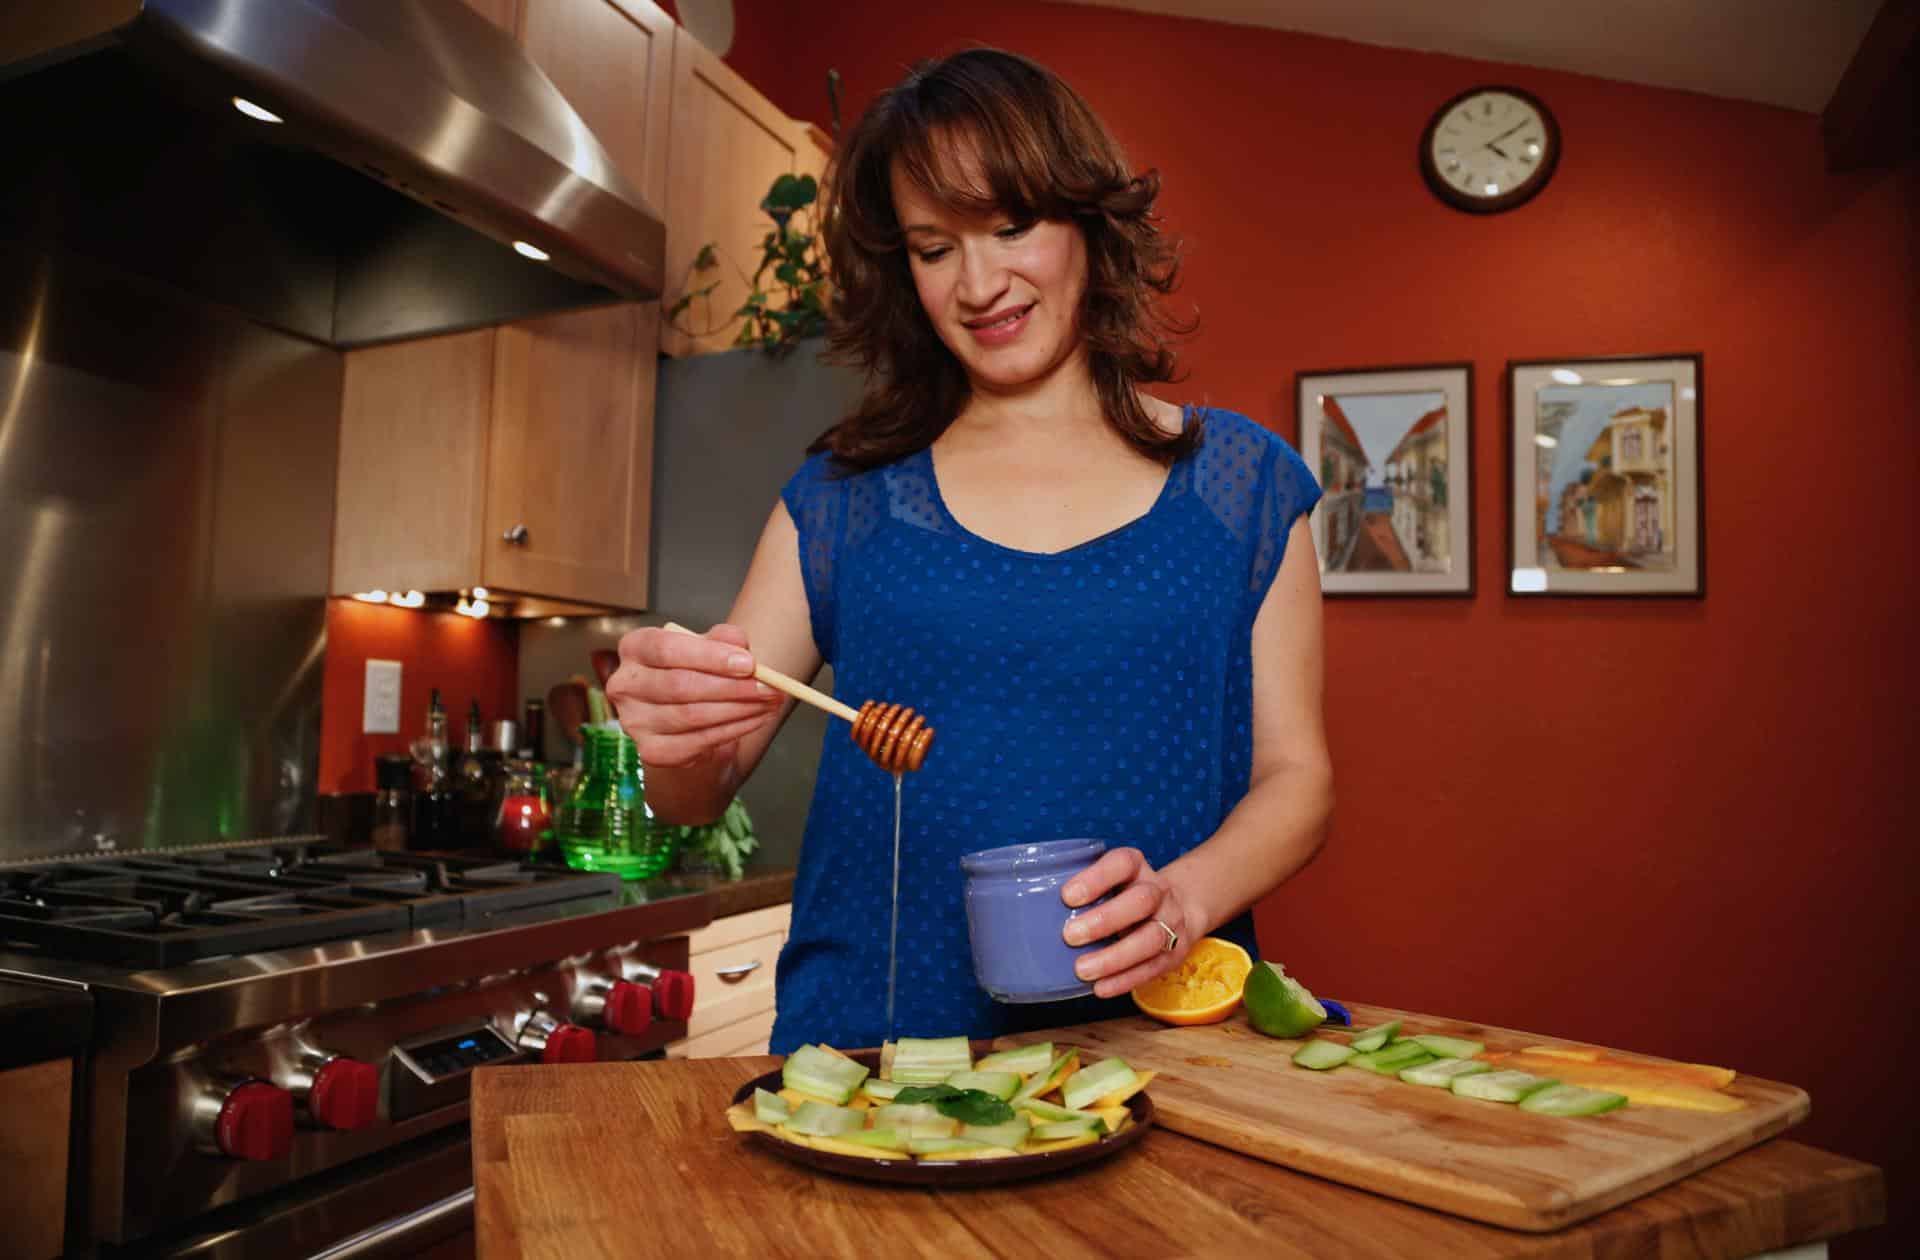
[321,599,520,793]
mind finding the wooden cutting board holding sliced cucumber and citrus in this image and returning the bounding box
[996,1005,1811,1231]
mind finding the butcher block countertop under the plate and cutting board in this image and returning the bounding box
[472,1035,1885,1260]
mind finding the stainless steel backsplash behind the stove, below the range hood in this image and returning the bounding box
[0,246,342,860]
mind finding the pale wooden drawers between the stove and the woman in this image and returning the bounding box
[666,903,793,1058]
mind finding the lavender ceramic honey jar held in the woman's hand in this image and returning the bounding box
[960,839,1106,1003]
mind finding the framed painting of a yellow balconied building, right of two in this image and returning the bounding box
[1507,353,1707,599]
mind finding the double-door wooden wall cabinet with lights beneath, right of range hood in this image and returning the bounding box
[332,303,659,615]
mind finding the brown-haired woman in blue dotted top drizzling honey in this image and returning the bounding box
[609,50,1332,1053]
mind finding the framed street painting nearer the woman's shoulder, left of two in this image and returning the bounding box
[1294,363,1475,597]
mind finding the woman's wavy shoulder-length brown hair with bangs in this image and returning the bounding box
[808,48,1200,469]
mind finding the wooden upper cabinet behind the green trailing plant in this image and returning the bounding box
[660,29,826,357]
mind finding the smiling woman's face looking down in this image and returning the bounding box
[893,156,1087,392]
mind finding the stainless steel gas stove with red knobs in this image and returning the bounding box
[0,839,710,1256]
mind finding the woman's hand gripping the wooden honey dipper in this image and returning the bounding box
[607,624,785,774]
